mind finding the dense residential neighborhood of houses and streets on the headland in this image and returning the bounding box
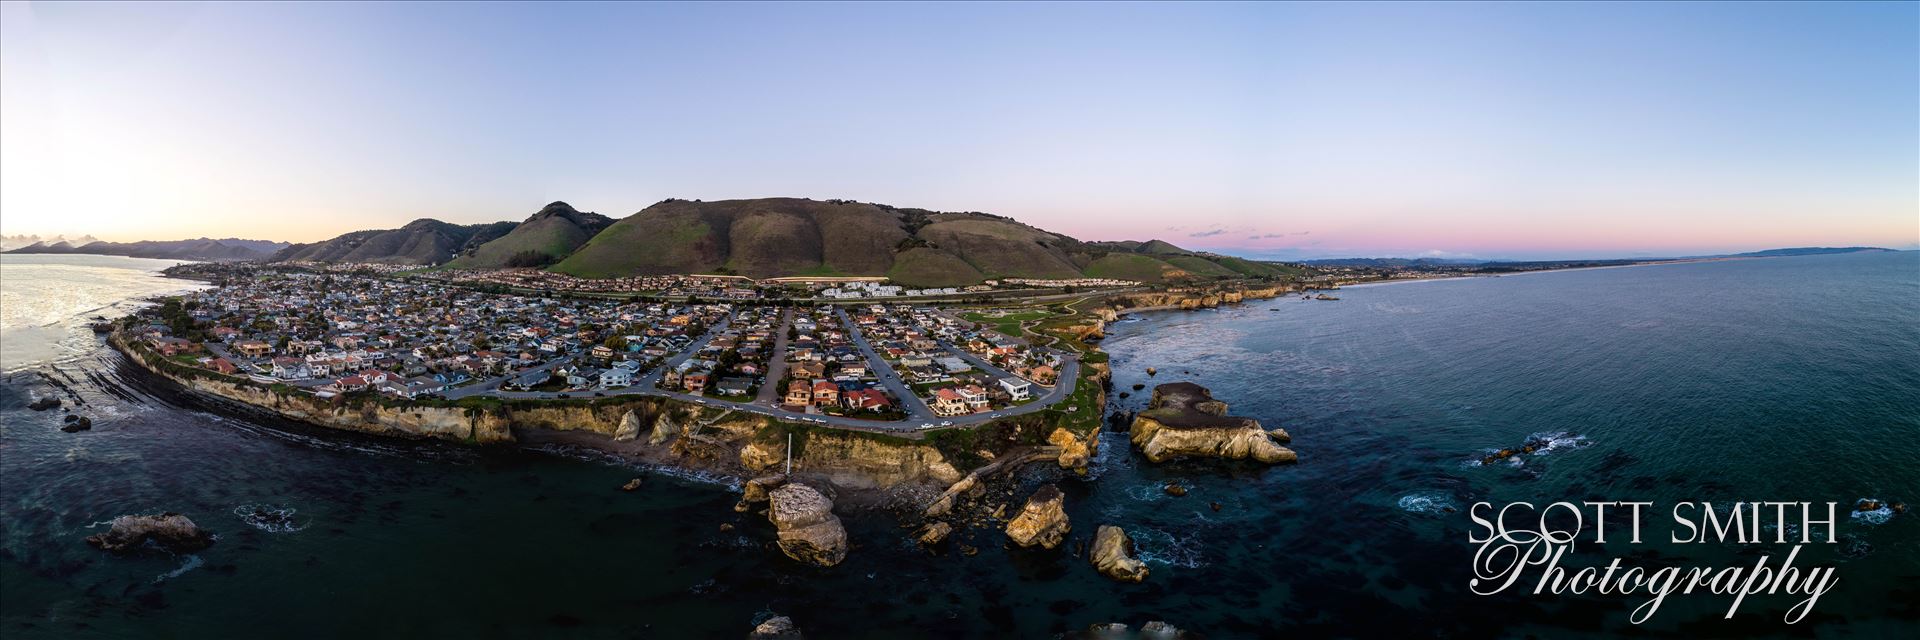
[127,261,1064,429]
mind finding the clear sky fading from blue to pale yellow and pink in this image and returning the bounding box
[0,2,1920,259]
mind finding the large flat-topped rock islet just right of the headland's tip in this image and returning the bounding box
[1129,382,1298,463]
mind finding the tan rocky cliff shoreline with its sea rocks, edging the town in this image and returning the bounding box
[90,288,1298,636]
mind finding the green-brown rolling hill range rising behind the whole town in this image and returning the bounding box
[275,198,1305,286]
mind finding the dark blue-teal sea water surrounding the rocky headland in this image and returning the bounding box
[0,252,1920,638]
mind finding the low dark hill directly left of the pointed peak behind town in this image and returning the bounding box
[271,217,518,265]
